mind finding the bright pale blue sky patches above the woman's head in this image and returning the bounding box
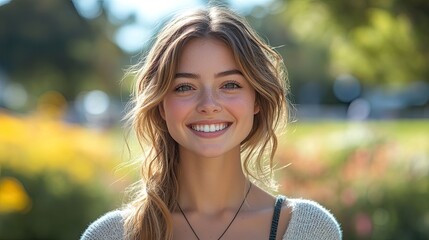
[72,0,272,53]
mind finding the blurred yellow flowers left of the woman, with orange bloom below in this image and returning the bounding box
[0,109,120,213]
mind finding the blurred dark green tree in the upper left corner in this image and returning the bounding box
[0,0,125,102]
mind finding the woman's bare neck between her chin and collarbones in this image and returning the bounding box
[178,149,249,214]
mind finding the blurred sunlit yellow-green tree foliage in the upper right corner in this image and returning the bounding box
[279,0,429,86]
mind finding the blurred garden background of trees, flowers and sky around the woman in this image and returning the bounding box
[0,0,429,239]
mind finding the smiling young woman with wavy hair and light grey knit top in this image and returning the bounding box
[82,7,341,240]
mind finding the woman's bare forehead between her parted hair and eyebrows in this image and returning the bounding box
[178,38,238,71]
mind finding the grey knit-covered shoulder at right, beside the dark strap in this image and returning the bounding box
[283,199,342,240]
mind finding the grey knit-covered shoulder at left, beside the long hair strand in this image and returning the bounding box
[80,210,125,240]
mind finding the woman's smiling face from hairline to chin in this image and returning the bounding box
[160,38,259,158]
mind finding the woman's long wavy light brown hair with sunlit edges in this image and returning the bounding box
[125,7,288,240]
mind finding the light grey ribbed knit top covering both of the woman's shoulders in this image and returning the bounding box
[81,199,342,240]
